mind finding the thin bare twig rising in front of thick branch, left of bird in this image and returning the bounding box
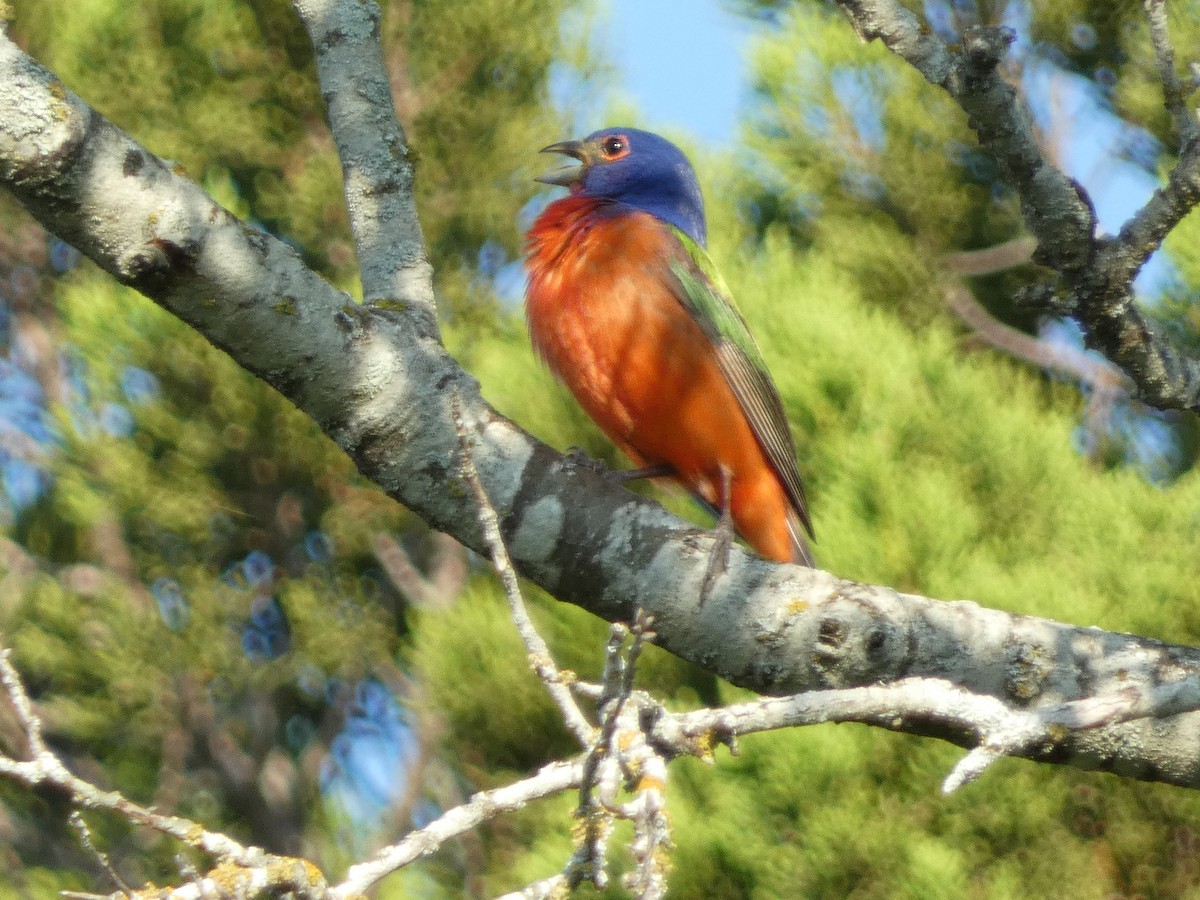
[452,394,595,749]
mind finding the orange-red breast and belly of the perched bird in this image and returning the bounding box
[526,196,796,562]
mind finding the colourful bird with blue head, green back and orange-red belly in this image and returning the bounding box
[524,127,815,571]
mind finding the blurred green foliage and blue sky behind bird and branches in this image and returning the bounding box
[0,0,1200,898]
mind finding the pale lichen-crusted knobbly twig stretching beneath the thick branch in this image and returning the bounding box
[44,662,1200,900]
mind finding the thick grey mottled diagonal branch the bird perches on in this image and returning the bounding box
[7,26,1200,786]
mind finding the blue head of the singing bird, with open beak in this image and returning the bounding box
[538,128,708,246]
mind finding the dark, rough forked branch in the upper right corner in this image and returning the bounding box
[838,0,1200,410]
